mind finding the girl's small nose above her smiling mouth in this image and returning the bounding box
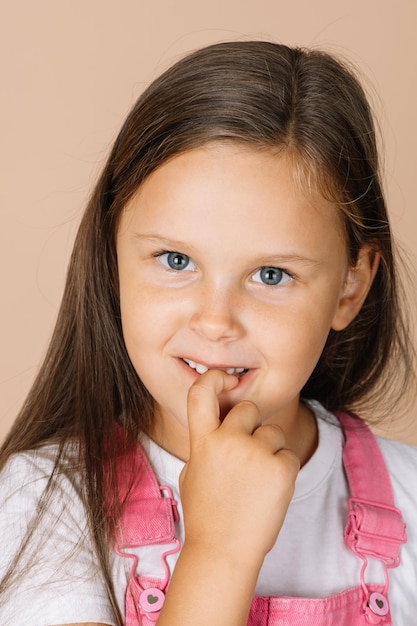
[189,286,244,341]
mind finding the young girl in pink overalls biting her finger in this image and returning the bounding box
[0,41,417,626]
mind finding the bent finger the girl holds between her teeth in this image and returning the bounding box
[187,370,238,447]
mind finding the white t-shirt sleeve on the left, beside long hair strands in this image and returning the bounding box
[0,450,116,626]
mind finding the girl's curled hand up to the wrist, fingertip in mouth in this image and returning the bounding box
[180,370,300,569]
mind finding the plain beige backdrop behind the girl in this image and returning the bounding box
[0,0,417,444]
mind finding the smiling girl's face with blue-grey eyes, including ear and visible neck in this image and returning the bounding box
[117,144,370,459]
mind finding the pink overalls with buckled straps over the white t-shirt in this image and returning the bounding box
[111,414,406,626]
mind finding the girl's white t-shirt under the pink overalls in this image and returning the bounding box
[0,403,417,626]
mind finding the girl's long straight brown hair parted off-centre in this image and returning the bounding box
[1,41,411,623]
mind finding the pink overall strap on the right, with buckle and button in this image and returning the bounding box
[337,413,407,623]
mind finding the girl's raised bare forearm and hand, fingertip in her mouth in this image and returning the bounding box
[158,370,299,626]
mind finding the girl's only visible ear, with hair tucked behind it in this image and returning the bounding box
[332,246,380,330]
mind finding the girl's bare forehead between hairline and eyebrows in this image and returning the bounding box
[121,143,343,254]
